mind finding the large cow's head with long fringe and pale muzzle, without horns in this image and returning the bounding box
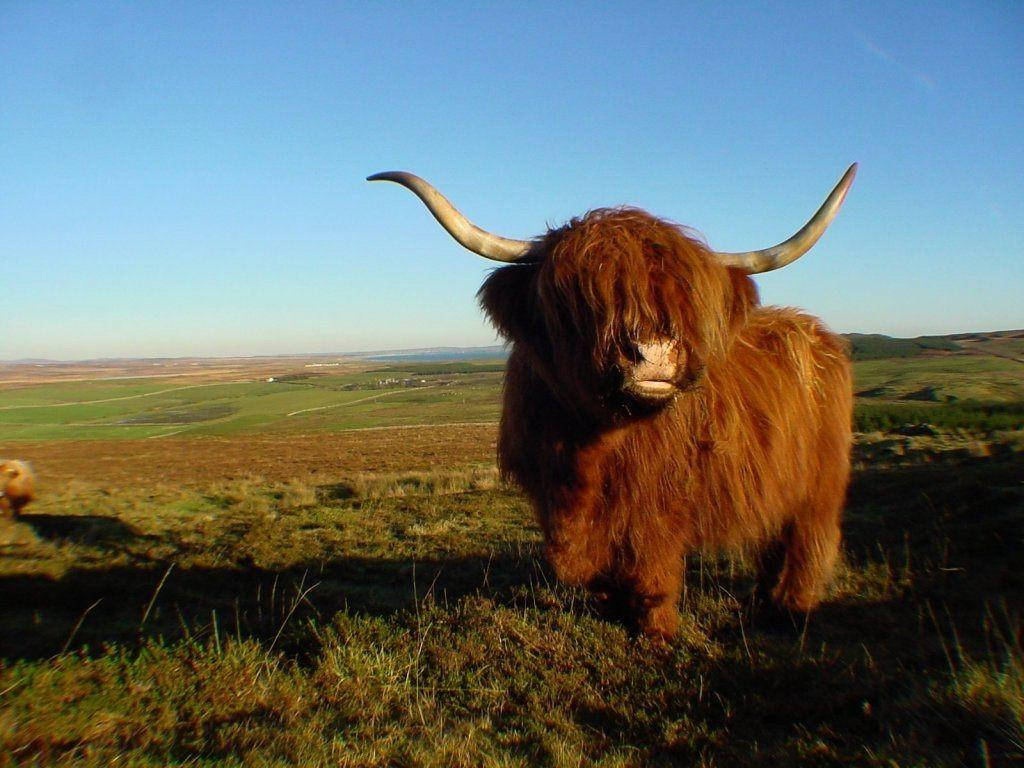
[480,209,756,418]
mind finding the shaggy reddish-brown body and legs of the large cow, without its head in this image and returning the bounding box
[499,307,852,635]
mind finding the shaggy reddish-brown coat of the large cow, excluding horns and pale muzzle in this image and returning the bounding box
[479,209,852,637]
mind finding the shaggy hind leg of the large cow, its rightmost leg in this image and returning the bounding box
[772,497,842,611]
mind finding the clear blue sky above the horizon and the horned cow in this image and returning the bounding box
[0,1,1024,358]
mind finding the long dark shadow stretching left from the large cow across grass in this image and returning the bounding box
[0,544,544,659]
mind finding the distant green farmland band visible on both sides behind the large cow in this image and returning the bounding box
[0,354,1024,440]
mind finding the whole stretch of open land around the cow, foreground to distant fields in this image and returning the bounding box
[0,355,1024,766]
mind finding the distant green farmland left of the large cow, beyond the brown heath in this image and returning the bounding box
[0,361,504,440]
